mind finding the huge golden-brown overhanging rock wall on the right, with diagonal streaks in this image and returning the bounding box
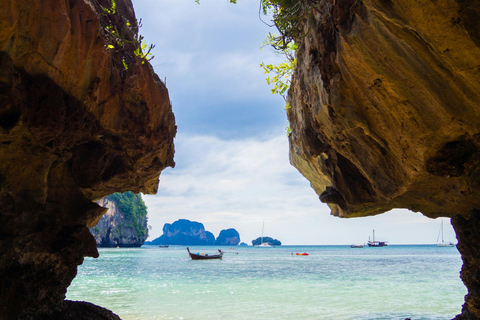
[288,0,480,319]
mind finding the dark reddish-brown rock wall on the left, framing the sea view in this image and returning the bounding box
[0,0,176,319]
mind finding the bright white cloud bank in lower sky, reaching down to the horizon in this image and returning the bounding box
[144,133,454,244]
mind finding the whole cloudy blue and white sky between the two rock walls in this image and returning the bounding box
[133,0,456,245]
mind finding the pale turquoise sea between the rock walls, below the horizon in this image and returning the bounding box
[67,245,467,320]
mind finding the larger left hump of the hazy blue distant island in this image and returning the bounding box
[148,219,215,246]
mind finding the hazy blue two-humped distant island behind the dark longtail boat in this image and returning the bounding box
[145,219,240,246]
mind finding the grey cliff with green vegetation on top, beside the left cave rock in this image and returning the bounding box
[90,191,148,247]
